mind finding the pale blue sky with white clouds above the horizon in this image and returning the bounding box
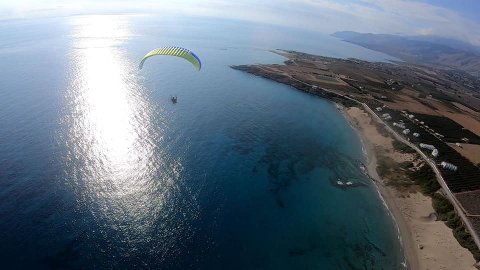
[0,0,480,46]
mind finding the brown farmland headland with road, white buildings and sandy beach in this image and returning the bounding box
[232,50,480,269]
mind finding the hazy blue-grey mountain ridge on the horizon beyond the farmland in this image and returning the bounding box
[332,31,480,77]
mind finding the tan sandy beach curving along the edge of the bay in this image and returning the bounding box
[341,107,476,270]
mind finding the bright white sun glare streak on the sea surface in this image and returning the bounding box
[61,16,182,247]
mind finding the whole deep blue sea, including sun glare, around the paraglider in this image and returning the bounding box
[0,15,403,269]
